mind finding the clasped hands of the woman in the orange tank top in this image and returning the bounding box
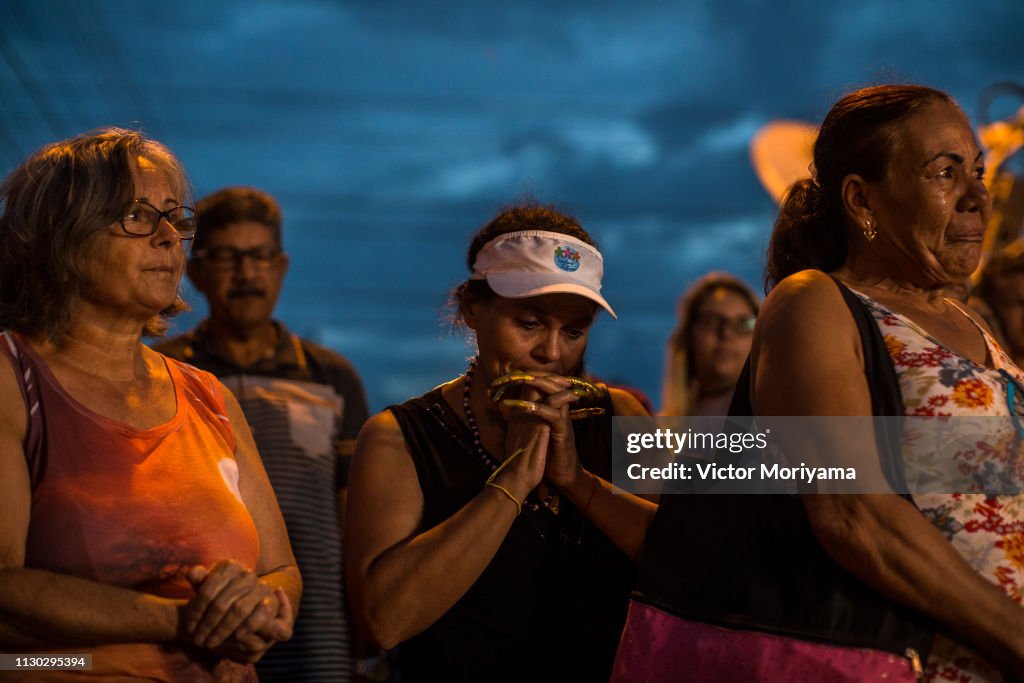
[182,560,295,663]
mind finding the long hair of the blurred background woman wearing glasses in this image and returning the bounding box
[662,270,761,415]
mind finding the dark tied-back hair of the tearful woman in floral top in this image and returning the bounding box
[765,85,955,292]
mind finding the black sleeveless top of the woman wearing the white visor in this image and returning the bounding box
[389,387,635,683]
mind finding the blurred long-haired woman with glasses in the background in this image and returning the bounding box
[660,272,759,416]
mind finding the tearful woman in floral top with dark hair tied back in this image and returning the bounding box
[751,86,1024,681]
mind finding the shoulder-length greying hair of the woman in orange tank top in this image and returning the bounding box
[0,128,188,341]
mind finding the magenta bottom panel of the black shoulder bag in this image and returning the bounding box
[611,600,918,683]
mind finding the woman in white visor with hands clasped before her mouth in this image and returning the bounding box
[346,206,654,683]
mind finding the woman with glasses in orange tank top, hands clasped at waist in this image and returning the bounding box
[0,129,301,681]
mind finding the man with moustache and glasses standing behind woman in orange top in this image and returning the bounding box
[156,187,368,681]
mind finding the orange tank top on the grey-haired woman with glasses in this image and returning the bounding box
[0,333,259,681]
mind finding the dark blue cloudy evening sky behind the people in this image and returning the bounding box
[0,0,1024,409]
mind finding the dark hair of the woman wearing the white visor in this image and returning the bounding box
[450,203,597,323]
